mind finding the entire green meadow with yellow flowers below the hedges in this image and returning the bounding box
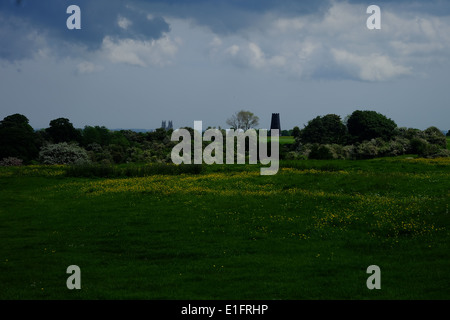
[0,158,450,300]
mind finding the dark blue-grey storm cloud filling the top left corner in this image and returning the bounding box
[0,0,170,60]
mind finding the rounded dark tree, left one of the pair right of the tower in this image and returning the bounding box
[299,114,347,144]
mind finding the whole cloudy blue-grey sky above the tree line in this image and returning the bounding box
[0,0,450,131]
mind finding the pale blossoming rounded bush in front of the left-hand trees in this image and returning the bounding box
[39,142,89,164]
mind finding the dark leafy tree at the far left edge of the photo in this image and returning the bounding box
[0,113,39,162]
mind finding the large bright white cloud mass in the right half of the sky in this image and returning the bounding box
[201,1,450,81]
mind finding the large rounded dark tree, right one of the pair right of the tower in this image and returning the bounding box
[347,110,397,142]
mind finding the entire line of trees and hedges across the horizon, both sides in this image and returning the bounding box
[0,110,450,165]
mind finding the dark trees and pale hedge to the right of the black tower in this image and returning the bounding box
[286,110,450,159]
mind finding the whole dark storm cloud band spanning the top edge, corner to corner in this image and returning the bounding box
[0,0,450,60]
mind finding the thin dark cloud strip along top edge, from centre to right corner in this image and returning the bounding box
[135,0,450,34]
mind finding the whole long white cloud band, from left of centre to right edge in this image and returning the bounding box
[89,1,450,81]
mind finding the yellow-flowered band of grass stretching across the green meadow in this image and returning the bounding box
[54,168,448,238]
